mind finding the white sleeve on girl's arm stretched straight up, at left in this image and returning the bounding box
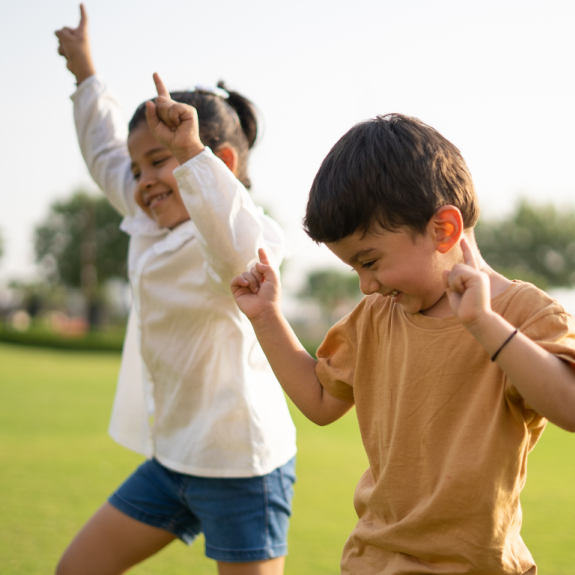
[71,76,137,216]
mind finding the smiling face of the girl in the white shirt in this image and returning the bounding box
[128,122,190,228]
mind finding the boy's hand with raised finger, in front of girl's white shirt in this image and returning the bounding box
[230,249,281,322]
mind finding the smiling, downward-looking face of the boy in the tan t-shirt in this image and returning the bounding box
[326,226,453,317]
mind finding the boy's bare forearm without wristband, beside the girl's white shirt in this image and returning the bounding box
[252,310,353,425]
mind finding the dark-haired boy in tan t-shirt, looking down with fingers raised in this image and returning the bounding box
[232,114,575,575]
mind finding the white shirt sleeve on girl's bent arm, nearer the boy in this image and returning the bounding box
[174,148,285,294]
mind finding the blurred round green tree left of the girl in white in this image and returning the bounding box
[35,190,128,327]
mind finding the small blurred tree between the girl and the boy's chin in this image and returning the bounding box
[298,269,363,325]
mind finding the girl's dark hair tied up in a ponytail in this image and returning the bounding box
[128,81,258,189]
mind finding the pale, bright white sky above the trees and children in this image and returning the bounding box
[0,0,575,290]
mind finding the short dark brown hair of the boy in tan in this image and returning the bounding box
[304,114,479,243]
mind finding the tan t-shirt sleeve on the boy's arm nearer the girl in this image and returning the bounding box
[316,312,357,402]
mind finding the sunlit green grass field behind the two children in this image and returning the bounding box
[0,345,575,575]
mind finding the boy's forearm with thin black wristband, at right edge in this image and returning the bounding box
[468,312,575,432]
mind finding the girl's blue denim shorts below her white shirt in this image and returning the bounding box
[109,457,296,563]
